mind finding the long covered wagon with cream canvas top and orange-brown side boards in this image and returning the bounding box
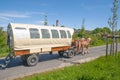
[0,23,91,68]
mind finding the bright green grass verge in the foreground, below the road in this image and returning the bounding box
[16,52,120,80]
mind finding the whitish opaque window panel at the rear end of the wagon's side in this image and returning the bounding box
[14,27,28,39]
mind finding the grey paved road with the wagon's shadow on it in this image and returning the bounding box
[0,44,120,80]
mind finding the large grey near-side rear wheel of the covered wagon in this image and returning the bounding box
[27,54,39,66]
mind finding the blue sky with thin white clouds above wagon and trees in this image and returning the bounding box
[0,0,120,30]
